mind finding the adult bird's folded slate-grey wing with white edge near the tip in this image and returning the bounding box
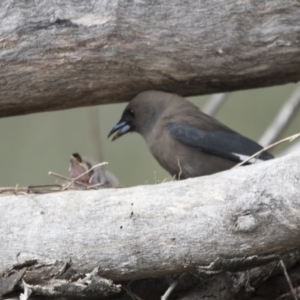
[167,123,273,163]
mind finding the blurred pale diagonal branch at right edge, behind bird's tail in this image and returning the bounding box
[259,85,300,146]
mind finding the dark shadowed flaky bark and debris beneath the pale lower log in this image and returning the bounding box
[0,252,300,300]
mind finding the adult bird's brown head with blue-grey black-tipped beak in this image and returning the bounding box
[108,91,167,141]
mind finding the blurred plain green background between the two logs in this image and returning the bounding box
[0,84,300,186]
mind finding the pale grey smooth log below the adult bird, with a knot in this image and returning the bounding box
[0,154,300,281]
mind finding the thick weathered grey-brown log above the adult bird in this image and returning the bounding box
[0,0,300,116]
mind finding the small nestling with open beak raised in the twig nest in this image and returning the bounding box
[69,153,120,189]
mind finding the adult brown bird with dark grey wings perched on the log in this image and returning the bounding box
[108,90,274,179]
